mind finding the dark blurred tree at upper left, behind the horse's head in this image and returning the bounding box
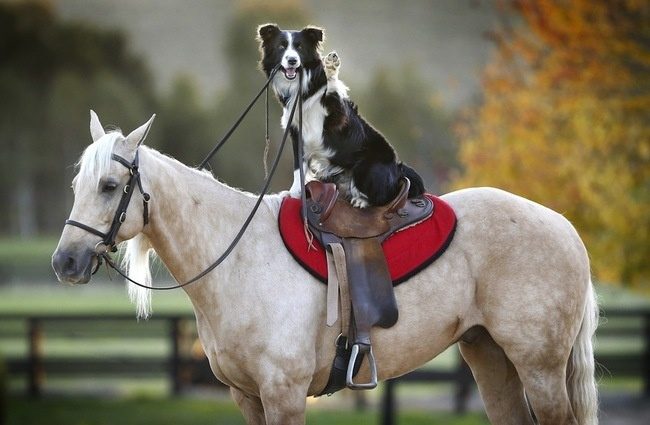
[0,1,154,236]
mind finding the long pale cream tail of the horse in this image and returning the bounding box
[567,281,598,425]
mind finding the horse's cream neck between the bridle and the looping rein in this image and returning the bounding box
[140,149,254,288]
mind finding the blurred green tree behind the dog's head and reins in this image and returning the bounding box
[211,0,310,191]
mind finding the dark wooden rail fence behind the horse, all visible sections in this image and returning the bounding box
[0,309,650,410]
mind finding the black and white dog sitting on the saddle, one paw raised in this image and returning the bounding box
[258,24,424,208]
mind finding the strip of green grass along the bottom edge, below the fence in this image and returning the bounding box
[6,398,488,425]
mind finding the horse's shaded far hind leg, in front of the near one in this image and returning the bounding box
[459,328,533,425]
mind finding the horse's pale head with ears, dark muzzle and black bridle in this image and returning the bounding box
[52,111,155,283]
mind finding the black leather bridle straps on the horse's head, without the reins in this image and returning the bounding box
[65,150,151,258]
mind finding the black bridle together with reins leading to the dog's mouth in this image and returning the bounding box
[65,65,304,291]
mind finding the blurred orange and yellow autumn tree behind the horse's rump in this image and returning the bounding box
[456,0,650,285]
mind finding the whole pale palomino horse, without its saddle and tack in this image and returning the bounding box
[53,113,598,425]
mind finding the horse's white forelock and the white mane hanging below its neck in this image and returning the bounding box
[77,131,155,318]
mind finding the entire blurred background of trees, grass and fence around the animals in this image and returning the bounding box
[0,0,650,424]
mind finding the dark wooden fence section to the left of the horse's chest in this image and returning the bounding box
[0,314,223,397]
